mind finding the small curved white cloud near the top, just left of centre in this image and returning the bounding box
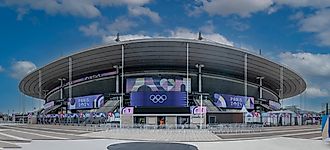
[128,6,161,23]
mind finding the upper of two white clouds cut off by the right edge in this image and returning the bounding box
[299,9,330,46]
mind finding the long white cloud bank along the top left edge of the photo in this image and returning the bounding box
[0,0,155,21]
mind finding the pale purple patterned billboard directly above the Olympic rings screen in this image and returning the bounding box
[126,77,191,93]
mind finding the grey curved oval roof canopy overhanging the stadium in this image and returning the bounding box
[19,38,306,98]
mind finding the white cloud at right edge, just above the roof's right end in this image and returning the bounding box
[280,52,330,77]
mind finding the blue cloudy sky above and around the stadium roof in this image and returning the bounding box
[0,0,330,112]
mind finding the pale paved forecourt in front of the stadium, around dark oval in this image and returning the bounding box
[0,125,330,150]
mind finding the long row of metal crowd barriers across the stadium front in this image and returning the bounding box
[34,117,264,134]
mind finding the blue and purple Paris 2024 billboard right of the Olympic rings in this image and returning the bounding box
[213,93,254,109]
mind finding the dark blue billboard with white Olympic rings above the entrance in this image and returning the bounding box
[131,91,187,107]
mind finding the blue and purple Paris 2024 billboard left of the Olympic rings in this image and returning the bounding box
[68,94,104,110]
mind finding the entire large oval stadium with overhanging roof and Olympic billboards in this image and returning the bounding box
[19,38,306,125]
